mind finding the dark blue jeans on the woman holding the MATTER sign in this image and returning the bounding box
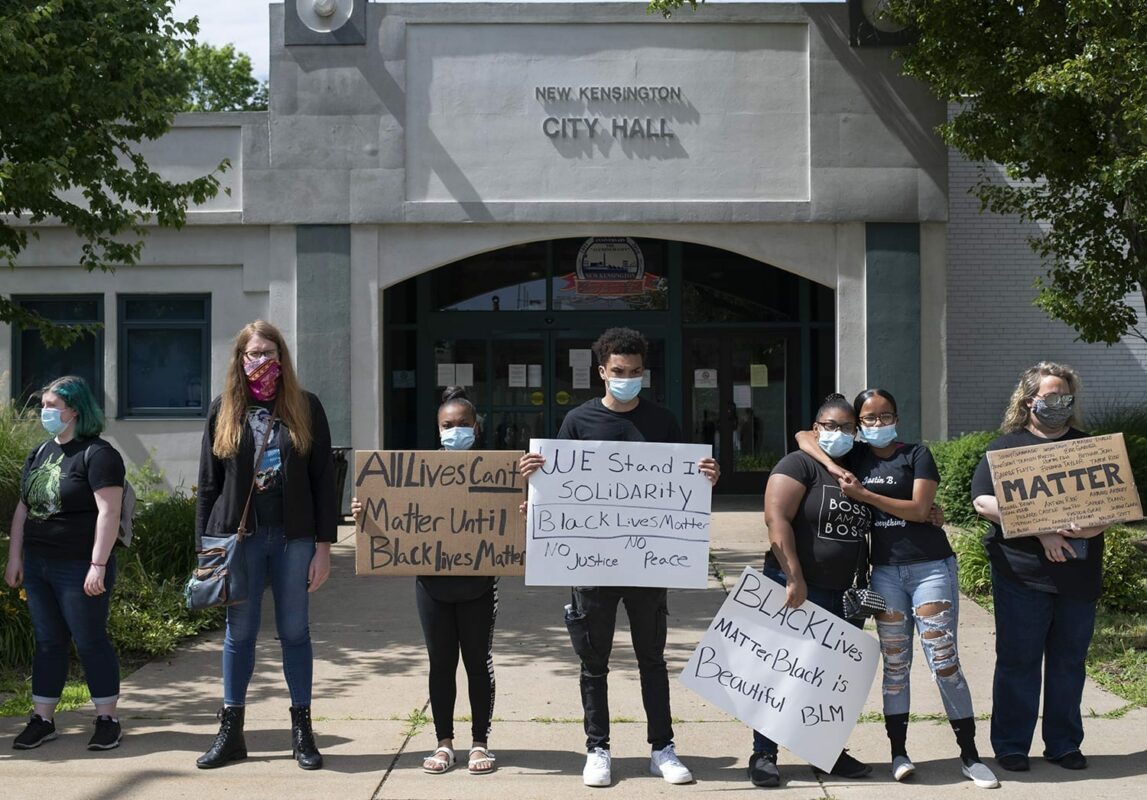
[992,569,1095,759]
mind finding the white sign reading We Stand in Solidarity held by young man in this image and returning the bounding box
[525,438,712,589]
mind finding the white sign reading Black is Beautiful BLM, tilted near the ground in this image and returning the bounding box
[681,567,880,771]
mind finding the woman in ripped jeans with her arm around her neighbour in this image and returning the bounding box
[798,389,999,789]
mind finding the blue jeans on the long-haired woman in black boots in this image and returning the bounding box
[223,528,314,706]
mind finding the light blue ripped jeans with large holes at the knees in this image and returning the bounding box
[872,556,973,720]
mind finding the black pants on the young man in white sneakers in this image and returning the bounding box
[565,587,673,749]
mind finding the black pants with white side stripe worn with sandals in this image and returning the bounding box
[414,581,498,741]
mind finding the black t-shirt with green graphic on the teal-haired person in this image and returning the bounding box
[19,437,124,561]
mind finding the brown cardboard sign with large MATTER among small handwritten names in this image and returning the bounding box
[988,434,1144,538]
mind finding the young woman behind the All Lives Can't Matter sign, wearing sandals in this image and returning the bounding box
[351,386,498,775]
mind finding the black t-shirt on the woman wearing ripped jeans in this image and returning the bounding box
[843,442,953,565]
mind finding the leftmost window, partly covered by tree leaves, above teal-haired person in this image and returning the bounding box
[11,295,103,406]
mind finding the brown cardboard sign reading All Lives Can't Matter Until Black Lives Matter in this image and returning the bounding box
[354,450,525,575]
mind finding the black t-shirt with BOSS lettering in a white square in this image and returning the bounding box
[765,451,872,590]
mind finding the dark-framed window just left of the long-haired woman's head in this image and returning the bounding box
[118,295,211,417]
